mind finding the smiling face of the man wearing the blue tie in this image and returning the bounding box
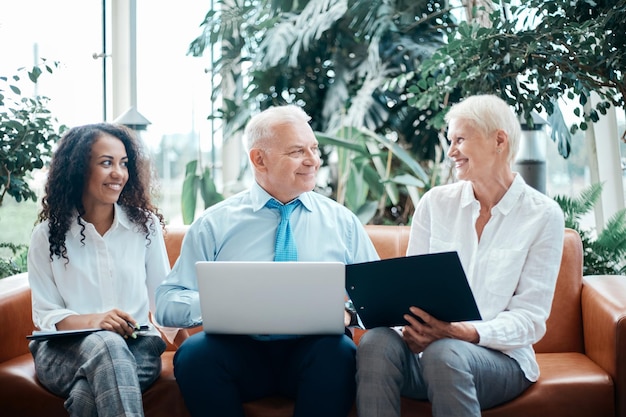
[252,119,321,203]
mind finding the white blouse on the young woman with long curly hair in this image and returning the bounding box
[28,205,170,335]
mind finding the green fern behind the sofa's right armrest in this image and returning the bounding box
[554,183,626,275]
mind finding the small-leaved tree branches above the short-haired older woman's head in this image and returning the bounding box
[400,0,626,157]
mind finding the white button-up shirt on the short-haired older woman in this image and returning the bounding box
[407,174,565,381]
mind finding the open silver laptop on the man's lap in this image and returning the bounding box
[196,262,346,335]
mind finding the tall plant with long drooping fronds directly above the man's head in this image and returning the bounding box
[189,0,452,146]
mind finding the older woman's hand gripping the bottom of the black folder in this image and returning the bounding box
[402,307,480,353]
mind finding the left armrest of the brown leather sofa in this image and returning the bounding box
[0,273,34,363]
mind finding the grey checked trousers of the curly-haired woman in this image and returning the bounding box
[29,331,165,417]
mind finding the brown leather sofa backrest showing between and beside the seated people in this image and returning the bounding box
[160,225,584,352]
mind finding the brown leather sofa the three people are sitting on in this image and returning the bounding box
[0,226,626,417]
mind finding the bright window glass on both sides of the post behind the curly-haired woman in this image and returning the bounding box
[0,0,219,249]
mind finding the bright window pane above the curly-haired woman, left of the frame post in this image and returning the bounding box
[0,0,103,125]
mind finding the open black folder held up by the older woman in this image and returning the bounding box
[346,252,481,329]
